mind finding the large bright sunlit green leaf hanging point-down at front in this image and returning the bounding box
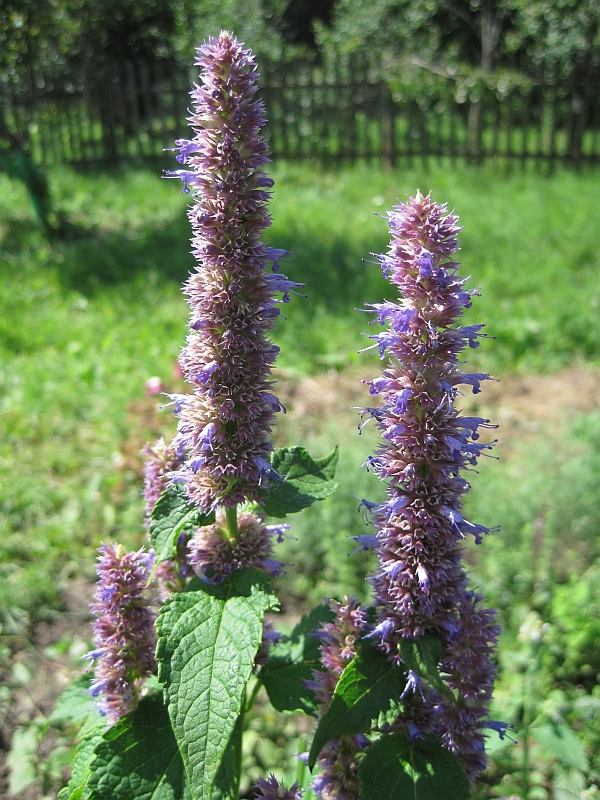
[156,569,277,800]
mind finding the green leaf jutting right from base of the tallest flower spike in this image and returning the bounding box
[264,447,339,517]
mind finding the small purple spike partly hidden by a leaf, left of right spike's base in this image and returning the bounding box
[308,597,369,800]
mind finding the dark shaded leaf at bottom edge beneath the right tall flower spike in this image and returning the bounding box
[358,733,471,800]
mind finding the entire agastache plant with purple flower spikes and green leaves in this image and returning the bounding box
[60,33,504,800]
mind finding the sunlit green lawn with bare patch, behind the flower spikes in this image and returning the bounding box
[0,163,600,798]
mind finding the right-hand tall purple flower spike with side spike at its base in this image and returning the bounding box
[363,193,498,777]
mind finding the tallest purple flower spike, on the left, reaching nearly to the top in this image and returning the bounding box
[167,33,298,510]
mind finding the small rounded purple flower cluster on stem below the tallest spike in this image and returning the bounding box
[188,509,290,583]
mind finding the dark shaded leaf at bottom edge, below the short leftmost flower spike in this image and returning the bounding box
[86,694,187,800]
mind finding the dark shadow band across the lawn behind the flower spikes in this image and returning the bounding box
[3,209,386,314]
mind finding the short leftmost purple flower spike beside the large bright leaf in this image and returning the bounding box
[86,544,156,723]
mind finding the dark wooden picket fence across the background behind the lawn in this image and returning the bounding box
[0,56,600,165]
